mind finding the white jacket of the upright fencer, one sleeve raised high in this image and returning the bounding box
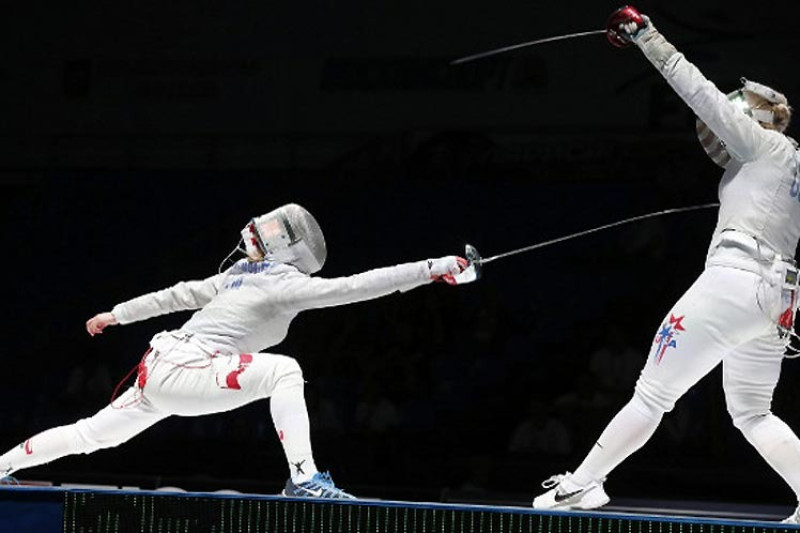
[636,29,800,264]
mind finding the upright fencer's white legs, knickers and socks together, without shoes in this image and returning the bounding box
[573,241,800,497]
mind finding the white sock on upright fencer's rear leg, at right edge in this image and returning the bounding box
[741,413,800,501]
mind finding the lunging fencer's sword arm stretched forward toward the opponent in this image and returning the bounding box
[276,256,467,311]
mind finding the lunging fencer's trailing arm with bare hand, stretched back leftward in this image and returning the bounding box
[86,274,225,336]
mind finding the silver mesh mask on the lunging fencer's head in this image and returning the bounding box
[241,204,327,274]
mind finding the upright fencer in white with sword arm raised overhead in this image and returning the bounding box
[533,6,800,523]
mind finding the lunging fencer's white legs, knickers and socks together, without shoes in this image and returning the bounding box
[0,332,316,475]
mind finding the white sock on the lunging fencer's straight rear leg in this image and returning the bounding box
[0,424,78,476]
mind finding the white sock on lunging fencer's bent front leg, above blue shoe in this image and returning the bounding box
[270,382,317,483]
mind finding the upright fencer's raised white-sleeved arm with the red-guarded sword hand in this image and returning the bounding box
[617,8,768,162]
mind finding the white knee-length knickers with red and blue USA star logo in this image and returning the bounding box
[636,265,785,414]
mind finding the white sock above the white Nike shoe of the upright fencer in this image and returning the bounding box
[571,396,661,486]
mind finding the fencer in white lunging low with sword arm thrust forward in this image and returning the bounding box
[0,204,466,499]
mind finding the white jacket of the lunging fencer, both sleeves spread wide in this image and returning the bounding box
[111,259,431,353]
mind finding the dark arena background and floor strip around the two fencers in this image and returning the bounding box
[0,0,800,533]
